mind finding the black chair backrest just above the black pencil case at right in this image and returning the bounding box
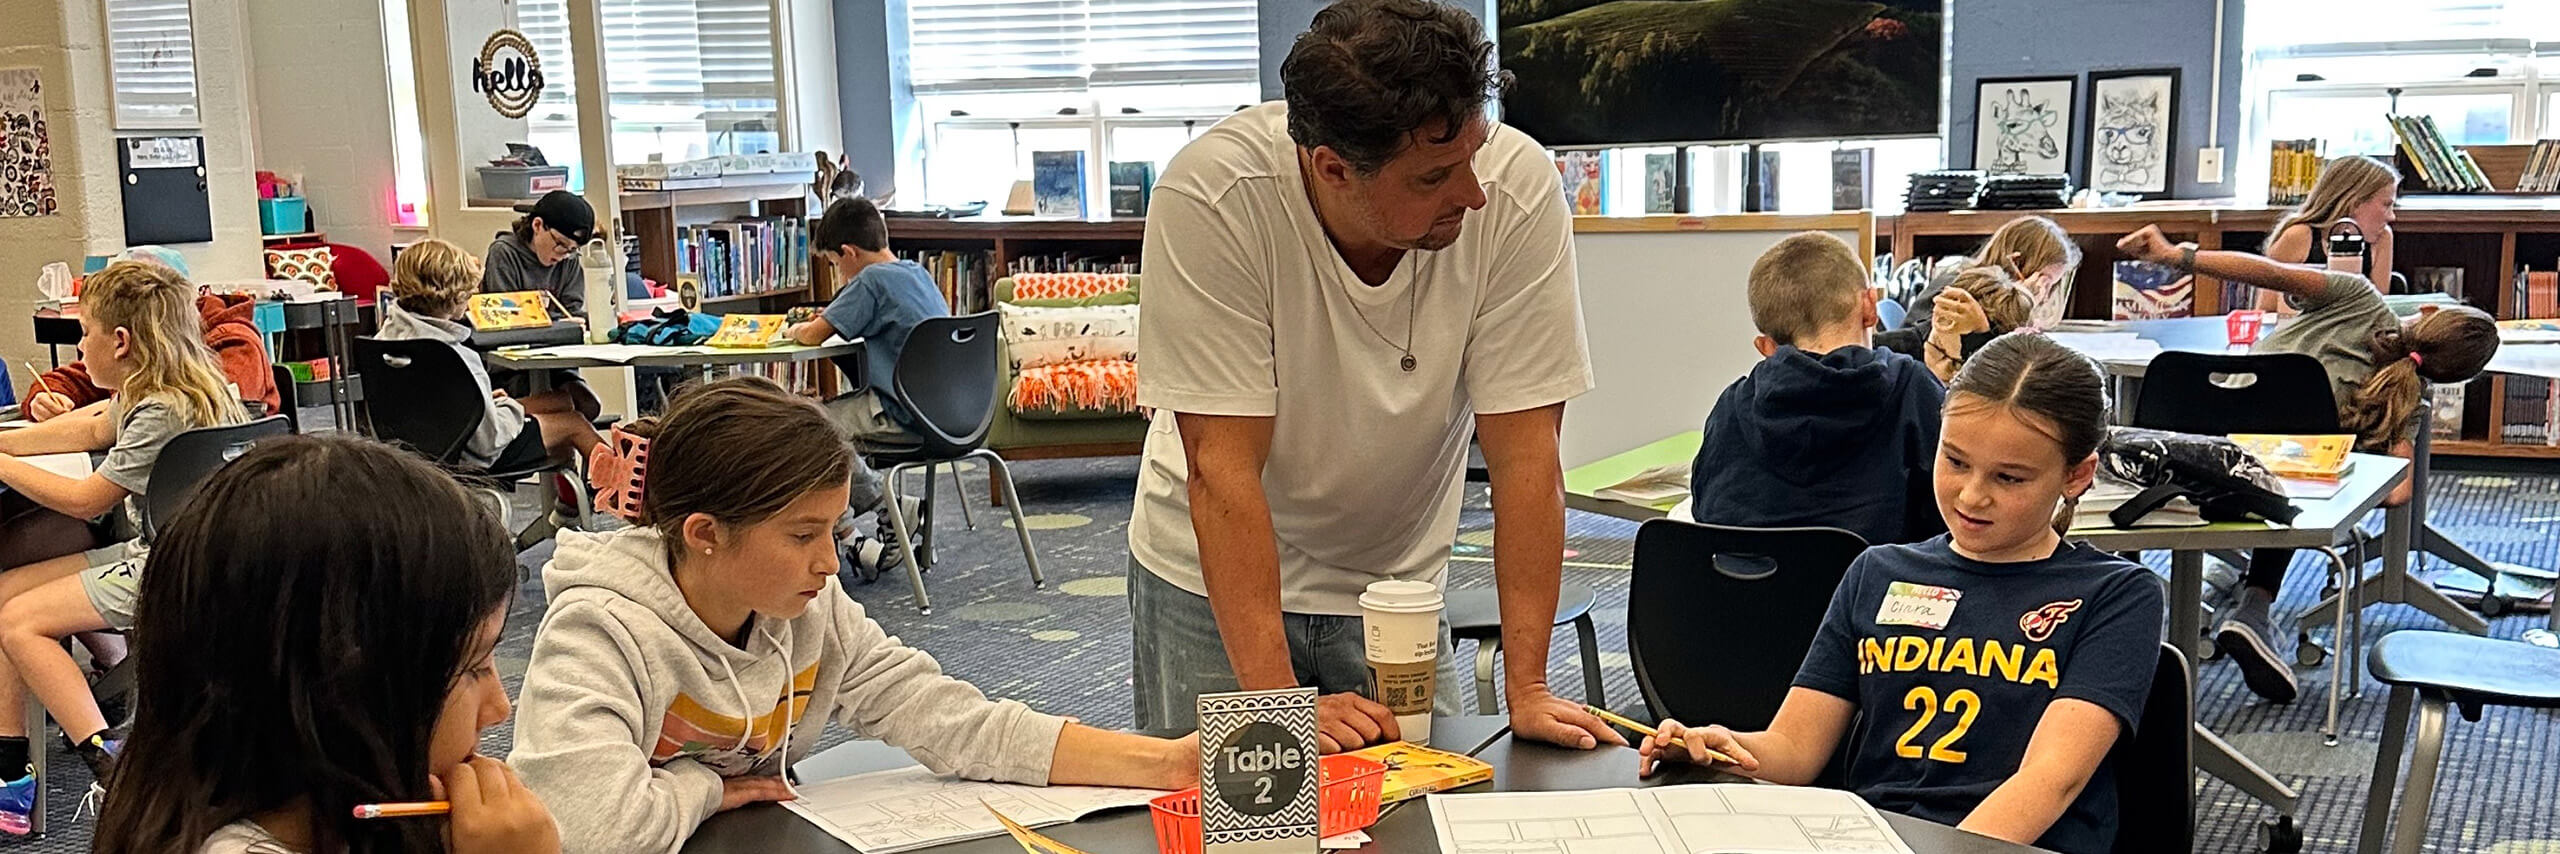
[2132,350,2337,435]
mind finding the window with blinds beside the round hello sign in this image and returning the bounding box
[517,0,783,184]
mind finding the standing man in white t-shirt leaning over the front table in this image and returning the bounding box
[1129,0,1623,752]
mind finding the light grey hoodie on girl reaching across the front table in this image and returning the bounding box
[507,529,1065,854]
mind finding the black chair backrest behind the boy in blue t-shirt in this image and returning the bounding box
[891,312,1001,458]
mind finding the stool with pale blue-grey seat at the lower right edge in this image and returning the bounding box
[2355,632,2560,854]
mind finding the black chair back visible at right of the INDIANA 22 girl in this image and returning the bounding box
[2109,644,2196,854]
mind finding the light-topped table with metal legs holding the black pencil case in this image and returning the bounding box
[2068,453,2414,816]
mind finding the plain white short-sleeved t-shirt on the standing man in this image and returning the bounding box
[1129,102,1592,614]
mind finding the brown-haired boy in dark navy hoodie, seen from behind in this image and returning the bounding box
[1690,233,1946,545]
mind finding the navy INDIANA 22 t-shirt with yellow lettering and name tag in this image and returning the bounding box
[1795,534,2166,854]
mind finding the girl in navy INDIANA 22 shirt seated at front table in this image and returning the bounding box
[1638,332,2163,854]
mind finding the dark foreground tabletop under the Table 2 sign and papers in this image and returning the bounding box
[684,716,2040,854]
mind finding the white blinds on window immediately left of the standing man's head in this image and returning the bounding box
[906,0,1260,92]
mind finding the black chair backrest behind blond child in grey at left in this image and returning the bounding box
[356,338,486,465]
